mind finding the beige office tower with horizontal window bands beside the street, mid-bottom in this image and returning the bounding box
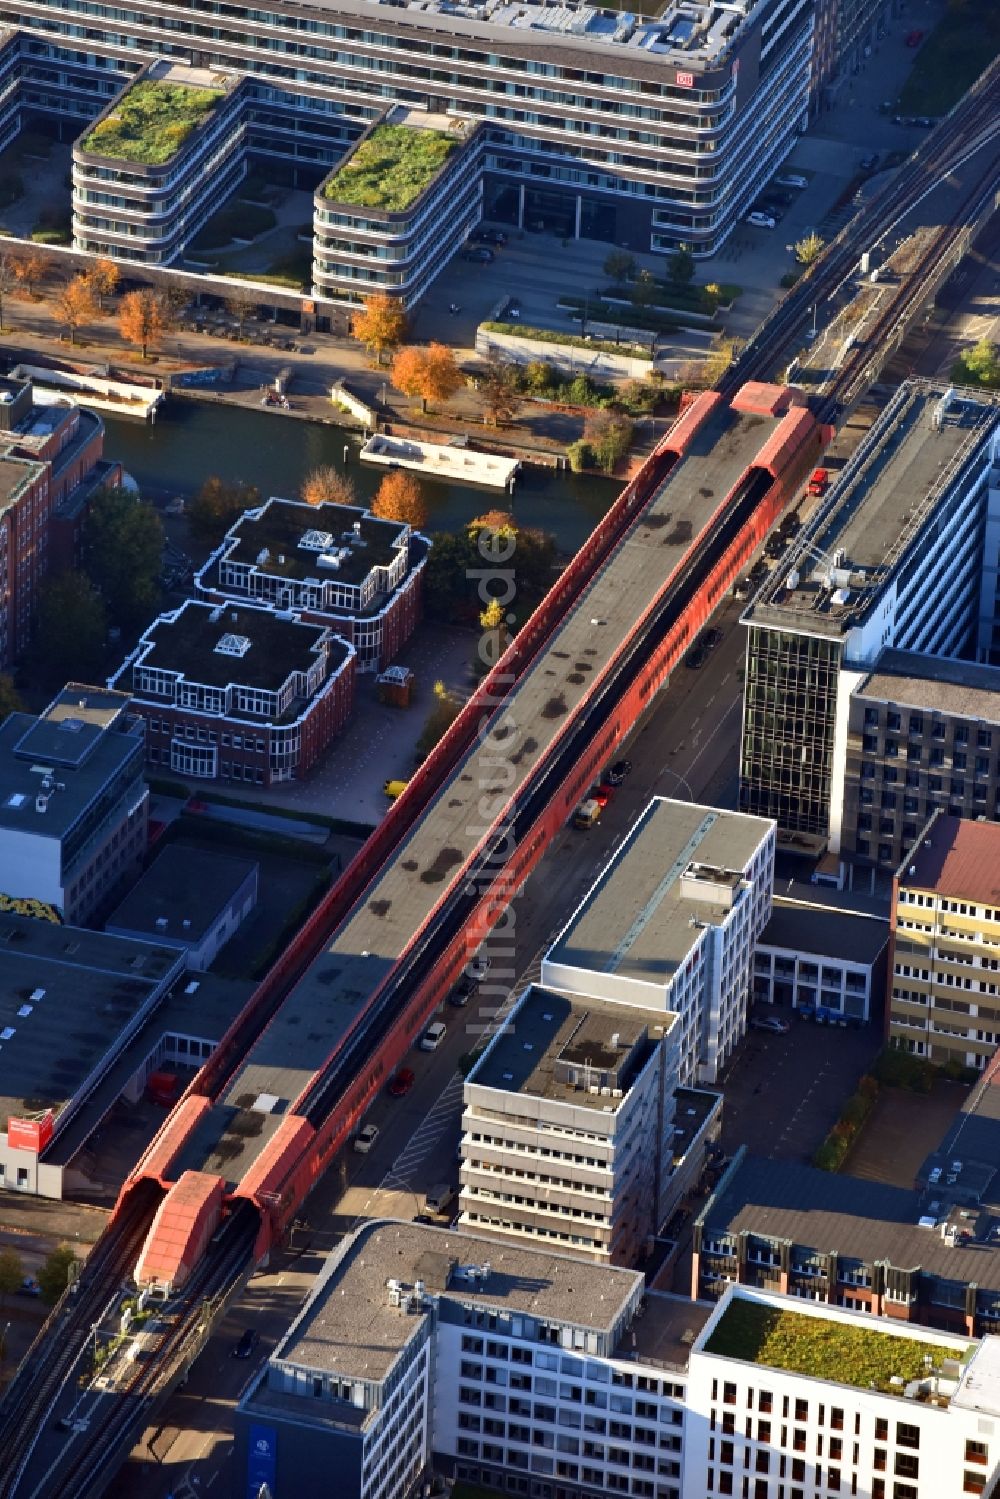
[460,986,710,1265]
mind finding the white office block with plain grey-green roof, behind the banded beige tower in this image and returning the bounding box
[541,797,775,1087]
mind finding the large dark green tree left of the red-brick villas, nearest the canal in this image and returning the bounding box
[84,489,163,627]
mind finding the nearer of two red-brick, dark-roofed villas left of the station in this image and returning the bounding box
[108,600,355,785]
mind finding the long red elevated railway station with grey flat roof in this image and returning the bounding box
[118,384,829,1292]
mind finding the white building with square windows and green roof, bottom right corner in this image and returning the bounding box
[684,1288,1000,1499]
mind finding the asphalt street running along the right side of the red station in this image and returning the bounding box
[115,572,744,1499]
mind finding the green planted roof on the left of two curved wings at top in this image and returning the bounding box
[78,63,229,166]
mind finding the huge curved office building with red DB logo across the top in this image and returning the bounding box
[0,0,816,255]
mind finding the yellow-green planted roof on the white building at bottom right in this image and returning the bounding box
[705,1298,971,1394]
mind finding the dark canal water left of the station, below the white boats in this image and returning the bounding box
[103,399,621,553]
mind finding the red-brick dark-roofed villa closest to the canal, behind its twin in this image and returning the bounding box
[195,499,430,672]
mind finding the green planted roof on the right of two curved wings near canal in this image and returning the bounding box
[324,124,460,213]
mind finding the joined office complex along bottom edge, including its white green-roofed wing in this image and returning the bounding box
[231,1222,1000,1499]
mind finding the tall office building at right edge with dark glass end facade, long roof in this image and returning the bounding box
[739,382,1000,853]
